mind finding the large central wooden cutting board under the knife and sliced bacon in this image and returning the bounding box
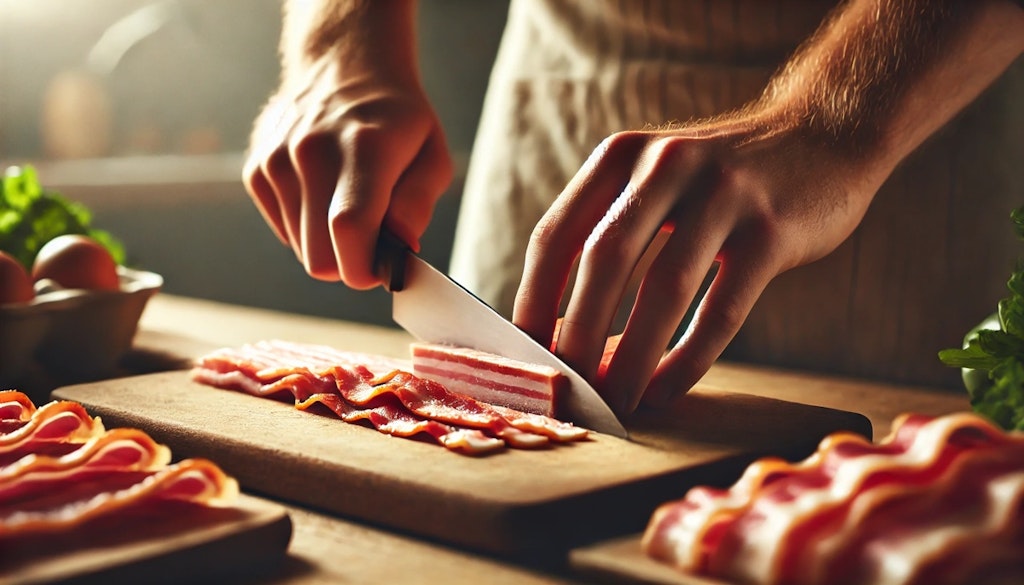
[53,372,871,557]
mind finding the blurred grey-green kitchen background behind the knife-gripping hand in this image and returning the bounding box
[0,0,508,325]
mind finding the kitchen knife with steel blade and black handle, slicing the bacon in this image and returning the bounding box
[376,229,629,438]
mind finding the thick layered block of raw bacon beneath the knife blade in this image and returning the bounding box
[411,343,566,416]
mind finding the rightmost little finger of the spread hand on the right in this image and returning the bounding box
[643,235,777,406]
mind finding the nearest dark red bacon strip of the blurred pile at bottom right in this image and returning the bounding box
[800,449,1024,583]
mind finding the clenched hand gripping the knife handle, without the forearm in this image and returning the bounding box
[244,3,452,289]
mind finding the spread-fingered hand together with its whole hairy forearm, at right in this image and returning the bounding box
[513,0,1024,413]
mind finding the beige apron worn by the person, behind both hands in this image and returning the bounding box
[451,0,1024,386]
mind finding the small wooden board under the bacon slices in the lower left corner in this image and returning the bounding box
[0,495,292,585]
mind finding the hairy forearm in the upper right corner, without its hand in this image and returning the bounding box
[761,0,1024,174]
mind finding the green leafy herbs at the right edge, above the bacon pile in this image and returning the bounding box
[939,207,1024,430]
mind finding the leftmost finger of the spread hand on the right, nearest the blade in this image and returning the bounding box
[512,132,644,347]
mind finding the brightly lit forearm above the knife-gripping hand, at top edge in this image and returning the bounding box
[280,0,419,90]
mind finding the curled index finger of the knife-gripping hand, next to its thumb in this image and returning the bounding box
[329,126,422,289]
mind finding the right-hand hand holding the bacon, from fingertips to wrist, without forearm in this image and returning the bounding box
[513,113,881,413]
